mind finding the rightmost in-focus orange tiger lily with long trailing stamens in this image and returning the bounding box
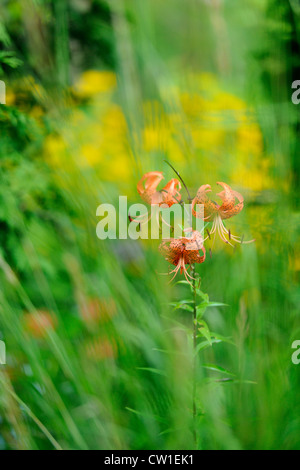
[192,182,254,246]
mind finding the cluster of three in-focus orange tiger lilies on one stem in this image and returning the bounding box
[137,171,254,282]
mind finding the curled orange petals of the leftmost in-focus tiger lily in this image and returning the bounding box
[137,171,181,207]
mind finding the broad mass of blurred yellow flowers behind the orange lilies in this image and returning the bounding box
[45,70,274,198]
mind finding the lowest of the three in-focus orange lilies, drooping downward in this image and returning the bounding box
[159,230,206,284]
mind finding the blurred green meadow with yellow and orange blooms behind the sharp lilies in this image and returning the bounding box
[0,0,300,450]
